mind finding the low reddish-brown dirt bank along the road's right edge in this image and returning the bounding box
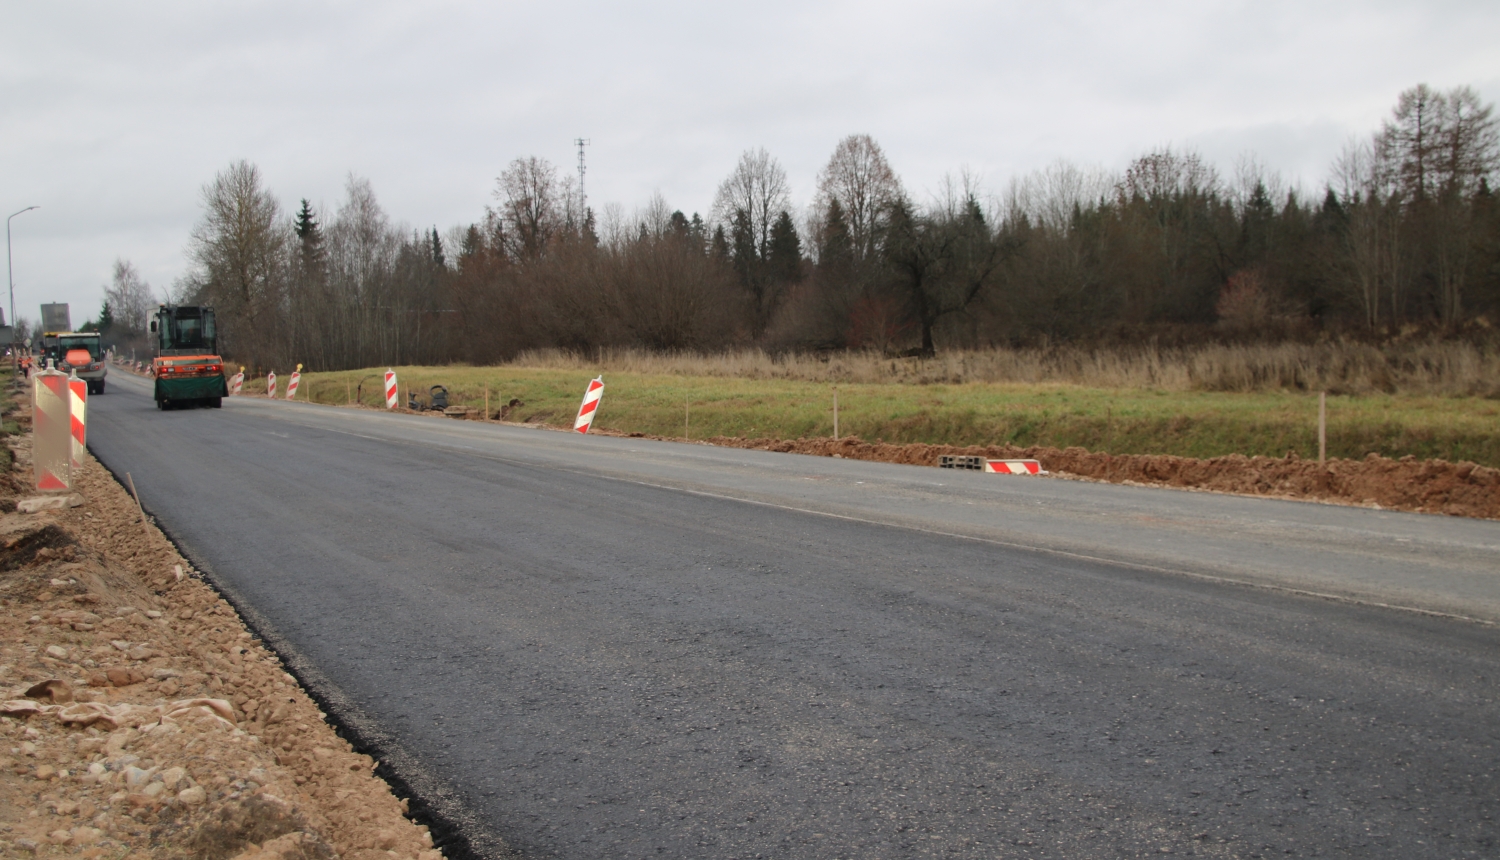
[707,437,1500,519]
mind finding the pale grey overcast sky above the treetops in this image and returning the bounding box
[0,0,1500,326]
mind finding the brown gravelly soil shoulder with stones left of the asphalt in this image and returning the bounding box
[0,390,441,860]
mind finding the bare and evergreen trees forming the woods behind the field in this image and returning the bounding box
[101,84,1500,369]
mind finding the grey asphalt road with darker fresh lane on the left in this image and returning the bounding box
[89,372,1500,858]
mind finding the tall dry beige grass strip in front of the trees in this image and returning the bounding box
[510,341,1500,398]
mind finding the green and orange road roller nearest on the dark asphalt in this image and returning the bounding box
[152,305,230,410]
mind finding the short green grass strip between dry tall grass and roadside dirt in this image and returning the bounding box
[289,366,1500,467]
